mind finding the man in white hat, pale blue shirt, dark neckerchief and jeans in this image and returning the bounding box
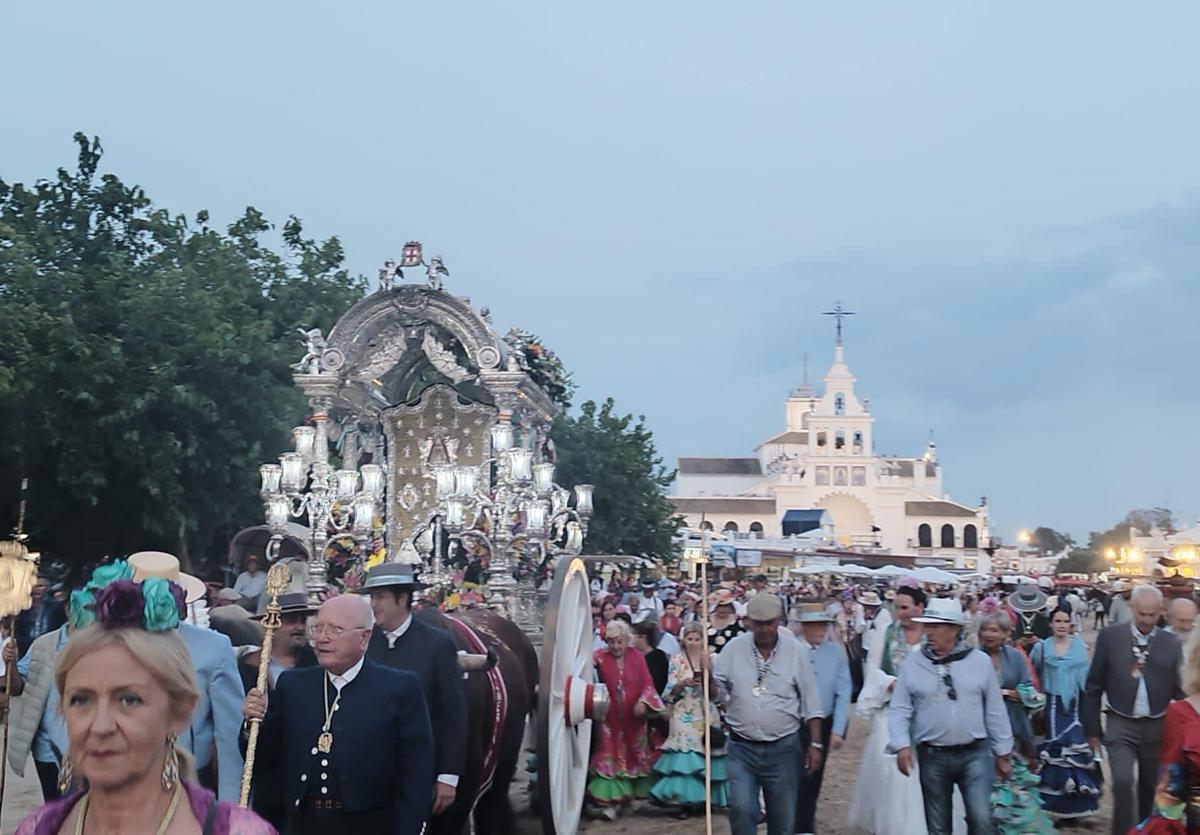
[888,599,1013,835]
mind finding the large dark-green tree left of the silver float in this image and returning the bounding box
[0,134,365,571]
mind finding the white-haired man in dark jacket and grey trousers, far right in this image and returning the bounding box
[1082,585,1183,835]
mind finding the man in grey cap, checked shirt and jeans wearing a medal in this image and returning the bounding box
[713,593,824,835]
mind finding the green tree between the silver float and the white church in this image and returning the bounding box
[552,398,682,560]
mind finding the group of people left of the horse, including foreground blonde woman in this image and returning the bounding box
[2,552,473,835]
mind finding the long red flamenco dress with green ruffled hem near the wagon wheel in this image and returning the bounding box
[587,649,664,806]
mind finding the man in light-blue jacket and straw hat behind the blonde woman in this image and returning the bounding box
[128,551,246,803]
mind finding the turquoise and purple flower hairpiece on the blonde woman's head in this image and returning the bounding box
[67,560,187,632]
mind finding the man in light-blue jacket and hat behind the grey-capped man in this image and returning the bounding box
[796,603,851,834]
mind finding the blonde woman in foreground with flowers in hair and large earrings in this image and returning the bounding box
[17,566,275,835]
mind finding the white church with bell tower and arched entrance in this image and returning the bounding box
[671,323,989,569]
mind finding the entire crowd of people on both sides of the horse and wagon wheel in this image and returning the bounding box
[7,552,1200,835]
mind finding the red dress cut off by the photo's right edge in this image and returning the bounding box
[1129,699,1200,835]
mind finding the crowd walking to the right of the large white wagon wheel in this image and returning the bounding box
[588,572,1200,835]
